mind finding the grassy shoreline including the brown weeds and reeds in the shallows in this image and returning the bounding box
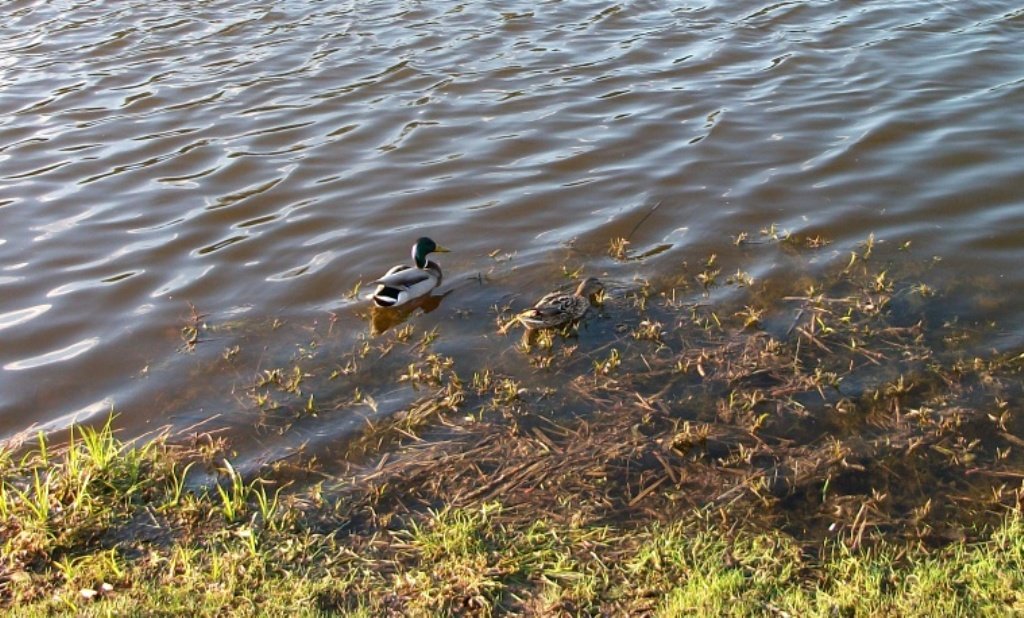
[0,238,1024,616]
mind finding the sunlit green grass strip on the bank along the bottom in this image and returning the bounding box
[0,424,1024,616]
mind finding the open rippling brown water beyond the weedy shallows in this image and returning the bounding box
[0,0,1024,453]
